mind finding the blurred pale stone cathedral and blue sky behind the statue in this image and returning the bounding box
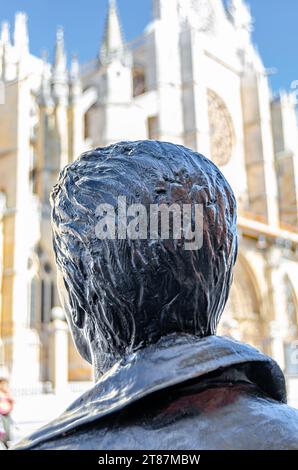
[0,0,298,446]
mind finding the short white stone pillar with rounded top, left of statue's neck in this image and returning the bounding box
[49,307,68,394]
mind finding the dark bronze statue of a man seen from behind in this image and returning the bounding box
[16,141,298,450]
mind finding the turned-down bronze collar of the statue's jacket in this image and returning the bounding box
[15,335,286,450]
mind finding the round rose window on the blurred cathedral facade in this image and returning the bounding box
[208,90,235,166]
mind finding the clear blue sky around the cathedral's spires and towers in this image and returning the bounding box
[0,0,298,90]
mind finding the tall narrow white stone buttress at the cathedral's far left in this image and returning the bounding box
[10,76,39,387]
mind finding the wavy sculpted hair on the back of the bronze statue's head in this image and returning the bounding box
[51,141,237,371]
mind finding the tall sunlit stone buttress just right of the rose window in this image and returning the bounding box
[242,64,279,227]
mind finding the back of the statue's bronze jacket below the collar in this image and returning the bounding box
[14,385,298,450]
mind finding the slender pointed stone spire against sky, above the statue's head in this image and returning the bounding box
[100,0,125,63]
